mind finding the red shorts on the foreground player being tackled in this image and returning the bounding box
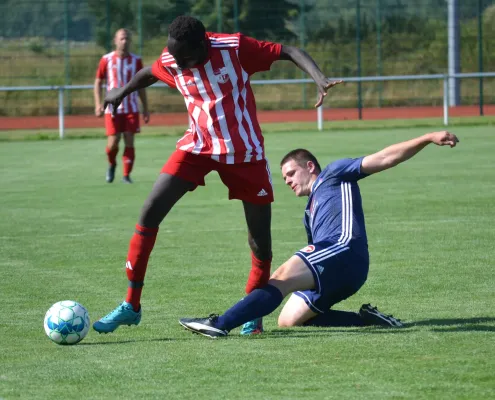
[162,150,273,204]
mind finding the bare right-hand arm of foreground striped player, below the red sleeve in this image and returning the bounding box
[280,45,343,107]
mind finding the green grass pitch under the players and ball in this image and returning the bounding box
[0,126,495,399]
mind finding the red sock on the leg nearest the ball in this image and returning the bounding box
[125,225,158,311]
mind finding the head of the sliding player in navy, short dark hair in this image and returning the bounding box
[280,149,321,197]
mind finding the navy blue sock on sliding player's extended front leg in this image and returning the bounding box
[216,285,284,331]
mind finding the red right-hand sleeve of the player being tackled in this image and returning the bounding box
[239,34,282,75]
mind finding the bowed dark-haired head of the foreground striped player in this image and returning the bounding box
[167,15,208,68]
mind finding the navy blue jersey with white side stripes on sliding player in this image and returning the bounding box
[304,157,368,250]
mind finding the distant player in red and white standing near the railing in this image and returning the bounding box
[94,29,150,183]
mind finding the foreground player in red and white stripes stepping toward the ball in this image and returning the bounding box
[93,16,340,334]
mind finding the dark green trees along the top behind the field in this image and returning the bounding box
[0,0,495,47]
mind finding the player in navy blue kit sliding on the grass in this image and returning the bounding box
[179,131,459,338]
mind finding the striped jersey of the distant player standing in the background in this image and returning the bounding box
[96,51,143,114]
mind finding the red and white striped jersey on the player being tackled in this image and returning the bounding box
[152,32,282,164]
